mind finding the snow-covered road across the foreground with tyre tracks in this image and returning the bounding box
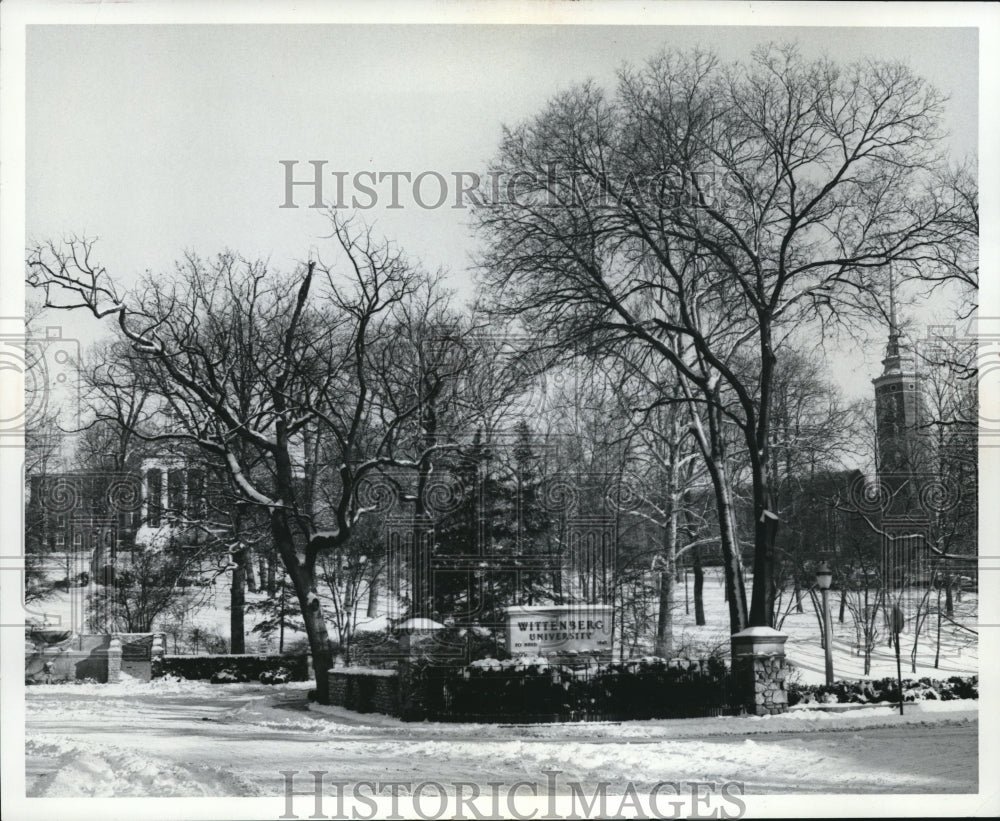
[27,682,978,796]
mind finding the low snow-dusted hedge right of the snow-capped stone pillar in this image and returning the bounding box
[788,676,979,707]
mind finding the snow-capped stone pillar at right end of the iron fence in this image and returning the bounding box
[730,627,788,716]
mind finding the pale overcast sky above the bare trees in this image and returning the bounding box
[26,25,978,395]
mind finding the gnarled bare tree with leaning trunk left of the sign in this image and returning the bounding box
[28,212,458,700]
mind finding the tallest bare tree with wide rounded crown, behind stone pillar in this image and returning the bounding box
[479,46,965,630]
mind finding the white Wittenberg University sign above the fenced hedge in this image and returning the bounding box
[507,604,612,656]
